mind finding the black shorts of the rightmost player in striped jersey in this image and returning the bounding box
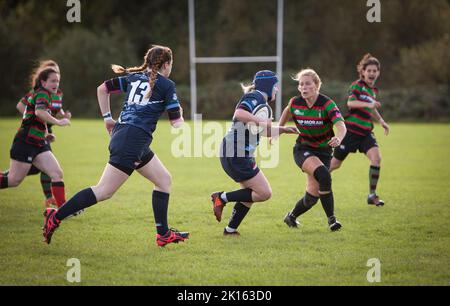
[333,132,378,160]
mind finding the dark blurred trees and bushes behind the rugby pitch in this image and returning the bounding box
[0,0,450,121]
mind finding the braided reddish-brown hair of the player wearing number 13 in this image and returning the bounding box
[111,45,172,98]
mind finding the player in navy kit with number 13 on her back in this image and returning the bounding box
[43,46,189,246]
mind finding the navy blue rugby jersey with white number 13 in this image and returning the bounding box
[105,72,180,134]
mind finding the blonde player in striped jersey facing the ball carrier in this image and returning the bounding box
[280,69,346,231]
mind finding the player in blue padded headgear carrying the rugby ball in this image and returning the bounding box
[211,70,297,236]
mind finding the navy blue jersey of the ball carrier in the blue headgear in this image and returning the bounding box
[224,90,267,157]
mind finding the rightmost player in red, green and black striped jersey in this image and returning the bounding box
[330,54,389,206]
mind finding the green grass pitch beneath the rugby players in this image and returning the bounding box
[0,118,450,286]
